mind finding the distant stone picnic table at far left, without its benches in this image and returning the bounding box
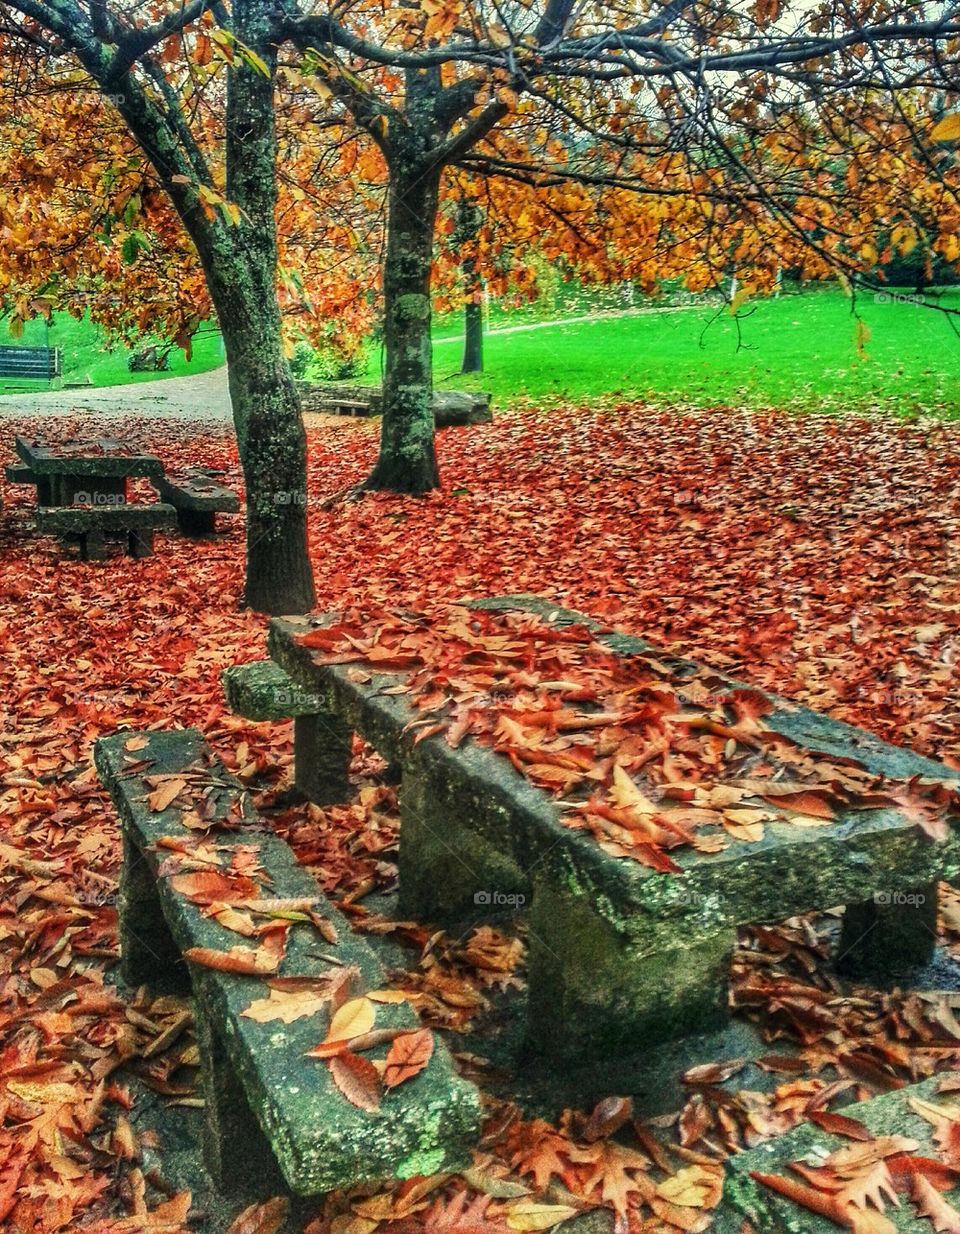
[16,437,163,506]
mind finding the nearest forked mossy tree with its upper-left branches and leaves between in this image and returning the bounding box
[0,0,315,612]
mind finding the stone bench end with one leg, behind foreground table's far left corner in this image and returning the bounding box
[220,660,353,806]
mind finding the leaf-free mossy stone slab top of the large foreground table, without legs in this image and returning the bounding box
[268,600,960,956]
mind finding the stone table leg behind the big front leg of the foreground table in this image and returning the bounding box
[400,771,529,923]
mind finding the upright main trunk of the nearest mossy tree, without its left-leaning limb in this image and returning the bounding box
[214,0,316,613]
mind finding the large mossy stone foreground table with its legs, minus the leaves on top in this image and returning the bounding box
[260,597,960,1059]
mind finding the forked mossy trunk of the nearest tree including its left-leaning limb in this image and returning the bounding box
[72,0,315,613]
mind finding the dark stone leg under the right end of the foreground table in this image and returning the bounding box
[837,882,937,979]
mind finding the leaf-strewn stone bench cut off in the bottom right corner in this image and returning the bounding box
[711,1076,960,1234]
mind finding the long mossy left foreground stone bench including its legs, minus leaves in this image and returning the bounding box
[94,729,480,1196]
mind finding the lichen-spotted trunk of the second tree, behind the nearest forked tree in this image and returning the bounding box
[365,70,442,494]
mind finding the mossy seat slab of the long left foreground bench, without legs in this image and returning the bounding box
[95,729,480,1196]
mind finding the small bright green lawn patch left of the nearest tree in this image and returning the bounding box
[0,313,223,391]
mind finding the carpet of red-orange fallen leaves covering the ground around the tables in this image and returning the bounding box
[0,407,960,1234]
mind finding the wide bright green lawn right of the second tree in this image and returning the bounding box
[369,288,960,417]
